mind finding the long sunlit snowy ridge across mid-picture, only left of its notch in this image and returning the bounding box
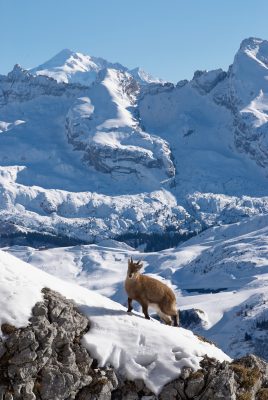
[0,167,194,241]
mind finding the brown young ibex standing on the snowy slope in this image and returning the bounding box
[125,257,178,326]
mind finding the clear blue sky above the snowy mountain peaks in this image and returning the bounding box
[0,0,268,82]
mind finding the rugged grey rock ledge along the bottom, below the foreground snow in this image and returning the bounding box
[0,288,268,400]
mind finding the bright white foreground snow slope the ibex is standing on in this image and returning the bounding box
[0,251,230,393]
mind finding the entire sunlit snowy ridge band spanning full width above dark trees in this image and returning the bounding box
[0,166,268,241]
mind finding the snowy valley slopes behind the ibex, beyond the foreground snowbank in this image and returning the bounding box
[8,215,268,359]
